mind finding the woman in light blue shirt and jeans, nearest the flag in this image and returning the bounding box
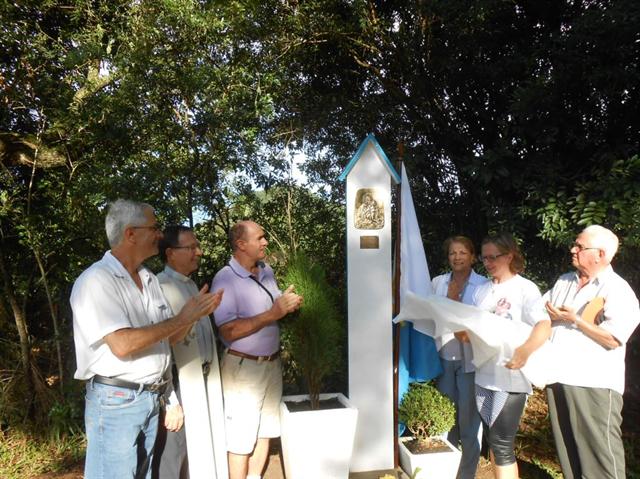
[432,236,487,479]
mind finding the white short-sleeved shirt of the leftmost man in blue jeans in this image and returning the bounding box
[70,251,171,384]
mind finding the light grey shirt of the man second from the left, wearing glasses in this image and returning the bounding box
[158,266,215,363]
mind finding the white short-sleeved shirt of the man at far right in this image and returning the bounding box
[544,266,640,394]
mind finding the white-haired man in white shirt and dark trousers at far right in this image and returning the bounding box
[544,225,640,479]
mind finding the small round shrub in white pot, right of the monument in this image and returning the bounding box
[398,383,461,479]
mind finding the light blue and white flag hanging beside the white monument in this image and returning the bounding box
[398,164,442,433]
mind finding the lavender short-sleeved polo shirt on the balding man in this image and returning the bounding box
[211,258,281,356]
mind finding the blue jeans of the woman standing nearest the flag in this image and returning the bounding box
[436,359,482,479]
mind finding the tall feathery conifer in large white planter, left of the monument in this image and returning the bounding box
[280,254,358,479]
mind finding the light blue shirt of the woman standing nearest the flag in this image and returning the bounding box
[431,270,487,373]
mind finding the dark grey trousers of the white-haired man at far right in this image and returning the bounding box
[547,383,625,479]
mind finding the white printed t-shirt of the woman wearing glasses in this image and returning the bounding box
[474,274,549,394]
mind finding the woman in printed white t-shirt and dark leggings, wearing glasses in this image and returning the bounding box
[473,233,551,479]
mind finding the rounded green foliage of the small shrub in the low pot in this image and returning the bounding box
[398,383,456,441]
